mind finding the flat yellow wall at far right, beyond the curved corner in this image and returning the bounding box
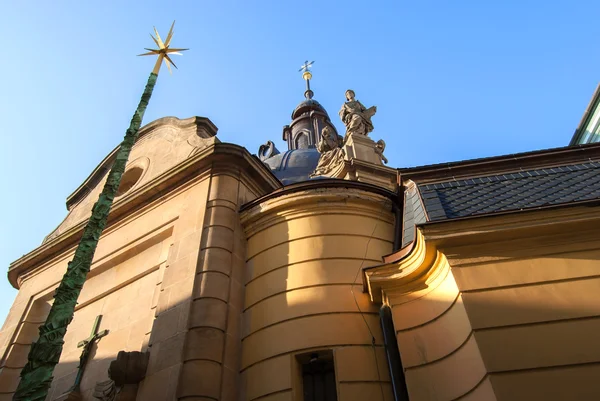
[453,242,600,401]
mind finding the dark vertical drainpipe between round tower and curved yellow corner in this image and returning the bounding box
[379,305,409,401]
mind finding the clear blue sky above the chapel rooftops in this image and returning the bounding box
[0,0,600,322]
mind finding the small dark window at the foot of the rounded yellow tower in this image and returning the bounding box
[298,351,337,401]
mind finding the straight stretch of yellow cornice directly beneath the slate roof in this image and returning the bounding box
[418,202,600,266]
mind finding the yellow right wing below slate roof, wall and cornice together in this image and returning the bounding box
[380,208,600,401]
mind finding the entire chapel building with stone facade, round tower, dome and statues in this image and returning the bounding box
[0,77,600,401]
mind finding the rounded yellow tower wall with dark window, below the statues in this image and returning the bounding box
[241,189,394,401]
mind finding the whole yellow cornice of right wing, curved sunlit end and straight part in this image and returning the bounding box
[363,202,600,302]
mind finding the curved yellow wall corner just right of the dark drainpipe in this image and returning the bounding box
[385,253,496,401]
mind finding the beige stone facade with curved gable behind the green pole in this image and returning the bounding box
[0,118,280,401]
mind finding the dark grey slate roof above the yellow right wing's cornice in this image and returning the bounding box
[418,161,600,222]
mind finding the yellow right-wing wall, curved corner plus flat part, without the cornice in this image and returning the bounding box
[390,244,600,401]
